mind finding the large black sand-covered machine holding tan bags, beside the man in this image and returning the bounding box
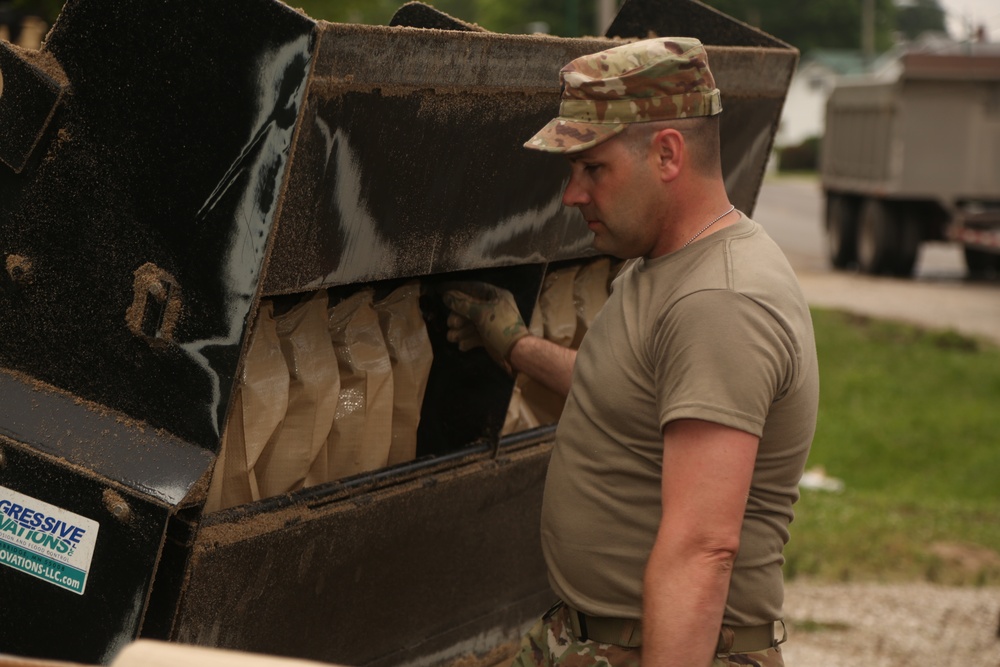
[0,0,798,666]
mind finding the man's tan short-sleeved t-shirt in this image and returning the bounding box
[542,217,819,625]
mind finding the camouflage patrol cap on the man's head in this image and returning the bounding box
[524,37,722,153]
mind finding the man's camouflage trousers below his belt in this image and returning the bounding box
[511,606,785,667]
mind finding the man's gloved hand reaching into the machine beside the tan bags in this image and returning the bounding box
[443,282,528,371]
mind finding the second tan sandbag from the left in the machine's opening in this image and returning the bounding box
[255,290,340,498]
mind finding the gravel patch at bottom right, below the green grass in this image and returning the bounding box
[784,581,1000,667]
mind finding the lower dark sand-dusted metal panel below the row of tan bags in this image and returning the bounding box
[173,445,553,665]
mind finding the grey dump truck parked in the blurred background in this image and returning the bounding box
[820,45,1000,277]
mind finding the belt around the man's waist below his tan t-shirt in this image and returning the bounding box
[564,605,785,653]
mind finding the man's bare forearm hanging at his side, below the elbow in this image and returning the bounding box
[642,545,735,667]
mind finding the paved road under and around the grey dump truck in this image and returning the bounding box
[754,178,1000,343]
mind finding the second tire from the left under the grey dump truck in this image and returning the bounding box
[858,198,916,275]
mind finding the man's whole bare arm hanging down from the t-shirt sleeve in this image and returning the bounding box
[642,419,758,667]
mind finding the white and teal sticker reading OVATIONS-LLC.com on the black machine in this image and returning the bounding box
[0,486,100,595]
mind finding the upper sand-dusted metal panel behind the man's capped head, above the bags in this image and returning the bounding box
[265,23,798,294]
